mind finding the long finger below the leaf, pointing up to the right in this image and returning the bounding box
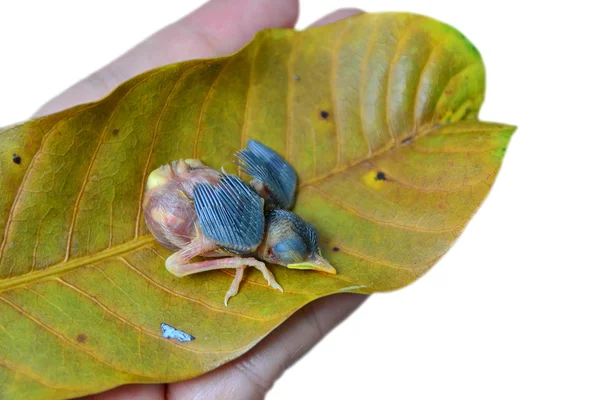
[167,293,367,400]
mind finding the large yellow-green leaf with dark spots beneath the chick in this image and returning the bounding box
[0,14,514,398]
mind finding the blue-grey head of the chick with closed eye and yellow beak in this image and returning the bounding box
[257,209,336,274]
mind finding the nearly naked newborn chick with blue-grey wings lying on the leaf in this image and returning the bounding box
[143,140,336,306]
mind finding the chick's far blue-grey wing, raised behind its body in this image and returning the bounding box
[235,140,298,210]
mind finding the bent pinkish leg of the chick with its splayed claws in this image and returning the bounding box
[166,240,283,306]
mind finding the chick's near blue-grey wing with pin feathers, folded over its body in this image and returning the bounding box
[194,175,265,254]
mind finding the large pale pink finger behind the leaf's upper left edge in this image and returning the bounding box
[35,0,298,116]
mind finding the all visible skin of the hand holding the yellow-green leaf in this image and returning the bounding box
[35,0,366,400]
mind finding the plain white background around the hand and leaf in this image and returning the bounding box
[0,0,600,399]
